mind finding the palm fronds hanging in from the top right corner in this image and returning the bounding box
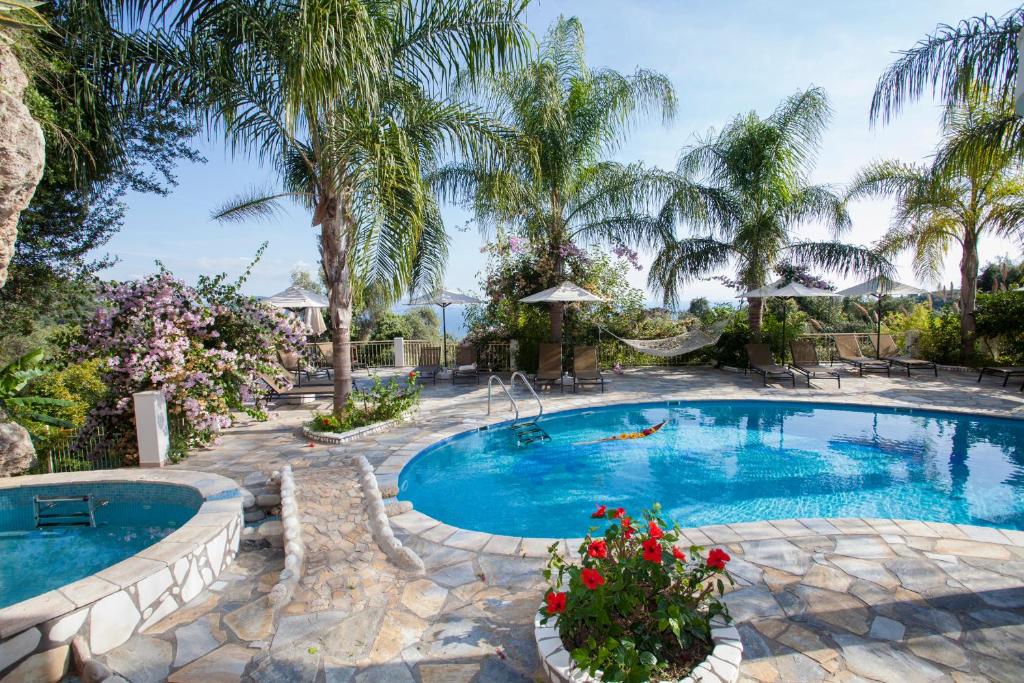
[870,6,1024,166]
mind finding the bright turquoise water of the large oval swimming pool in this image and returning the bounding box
[399,401,1024,538]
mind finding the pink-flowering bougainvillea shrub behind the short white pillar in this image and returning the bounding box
[75,271,307,450]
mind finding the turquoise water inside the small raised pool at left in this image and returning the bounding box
[0,483,203,607]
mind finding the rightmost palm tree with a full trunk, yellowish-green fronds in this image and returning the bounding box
[848,94,1024,362]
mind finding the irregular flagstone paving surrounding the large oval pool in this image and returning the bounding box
[88,369,1024,683]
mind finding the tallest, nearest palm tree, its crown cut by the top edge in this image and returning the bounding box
[174,0,529,414]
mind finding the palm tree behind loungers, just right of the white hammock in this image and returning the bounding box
[648,87,886,336]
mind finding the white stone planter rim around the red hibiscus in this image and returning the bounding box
[534,614,743,683]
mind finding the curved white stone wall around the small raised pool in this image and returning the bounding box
[0,470,242,682]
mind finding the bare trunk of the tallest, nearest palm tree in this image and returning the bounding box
[317,192,352,418]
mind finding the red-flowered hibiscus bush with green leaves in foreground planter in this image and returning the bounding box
[541,503,733,683]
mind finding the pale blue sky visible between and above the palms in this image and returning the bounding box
[100,0,1020,309]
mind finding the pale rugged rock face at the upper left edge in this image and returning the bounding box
[0,34,46,287]
